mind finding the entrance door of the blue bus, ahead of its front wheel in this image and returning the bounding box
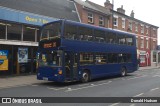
[65,52,78,81]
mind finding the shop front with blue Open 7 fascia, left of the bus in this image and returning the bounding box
[0,6,55,75]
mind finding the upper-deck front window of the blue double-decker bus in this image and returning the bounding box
[41,22,61,40]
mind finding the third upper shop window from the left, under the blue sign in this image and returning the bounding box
[23,26,36,42]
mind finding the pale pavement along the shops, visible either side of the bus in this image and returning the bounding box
[0,66,160,89]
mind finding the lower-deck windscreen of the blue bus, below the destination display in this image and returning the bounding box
[39,51,62,67]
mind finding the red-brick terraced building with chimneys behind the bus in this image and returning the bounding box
[74,0,158,66]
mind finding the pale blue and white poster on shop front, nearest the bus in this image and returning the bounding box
[18,48,28,63]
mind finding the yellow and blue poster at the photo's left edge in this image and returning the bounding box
[0,50,8,71]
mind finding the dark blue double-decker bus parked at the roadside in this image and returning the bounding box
[37,20,138,82]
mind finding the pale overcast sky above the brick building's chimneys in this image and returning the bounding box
[83,0,160,45]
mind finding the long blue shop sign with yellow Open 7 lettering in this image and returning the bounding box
[0,6,57,26]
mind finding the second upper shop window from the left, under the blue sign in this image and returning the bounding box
[7,24,22,40]
